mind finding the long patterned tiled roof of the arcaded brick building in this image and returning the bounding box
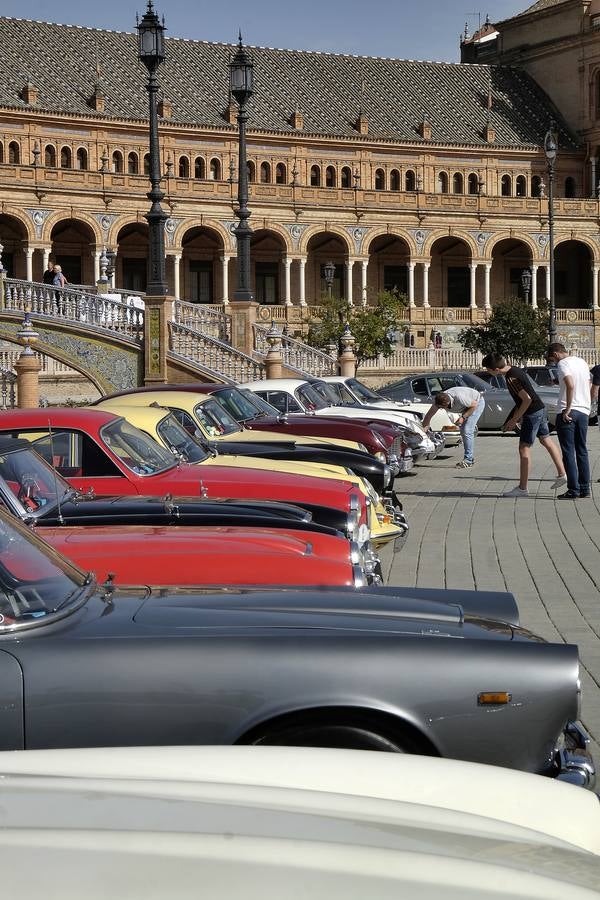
[0,18,578,147]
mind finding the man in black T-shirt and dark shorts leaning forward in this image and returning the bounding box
[481,353,567,497]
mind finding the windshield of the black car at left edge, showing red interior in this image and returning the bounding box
[0,448,73,516]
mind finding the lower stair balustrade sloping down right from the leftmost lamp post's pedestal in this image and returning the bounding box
[169,322,264,382]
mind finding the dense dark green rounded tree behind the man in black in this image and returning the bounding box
[458,299,548,362]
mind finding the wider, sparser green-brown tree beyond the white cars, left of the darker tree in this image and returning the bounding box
[306,291,407,368]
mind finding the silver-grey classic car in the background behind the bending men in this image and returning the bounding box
[380,371,556,431]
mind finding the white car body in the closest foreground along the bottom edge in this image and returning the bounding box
[0,747,600,900]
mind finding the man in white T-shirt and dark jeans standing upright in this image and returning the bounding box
[547,343,591,500]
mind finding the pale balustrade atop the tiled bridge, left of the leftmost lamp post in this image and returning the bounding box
[4,278,144,342]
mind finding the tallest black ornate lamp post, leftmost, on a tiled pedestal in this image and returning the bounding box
[136,0,168,297]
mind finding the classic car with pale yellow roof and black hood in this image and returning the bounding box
[91,385,393,494]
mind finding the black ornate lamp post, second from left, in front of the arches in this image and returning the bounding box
[229,32,254,300]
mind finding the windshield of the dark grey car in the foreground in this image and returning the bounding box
[0,509,90,634]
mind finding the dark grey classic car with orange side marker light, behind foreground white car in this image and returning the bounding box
[0,510,595,800]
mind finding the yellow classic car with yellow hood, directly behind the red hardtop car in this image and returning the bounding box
[95,404,408,549]
